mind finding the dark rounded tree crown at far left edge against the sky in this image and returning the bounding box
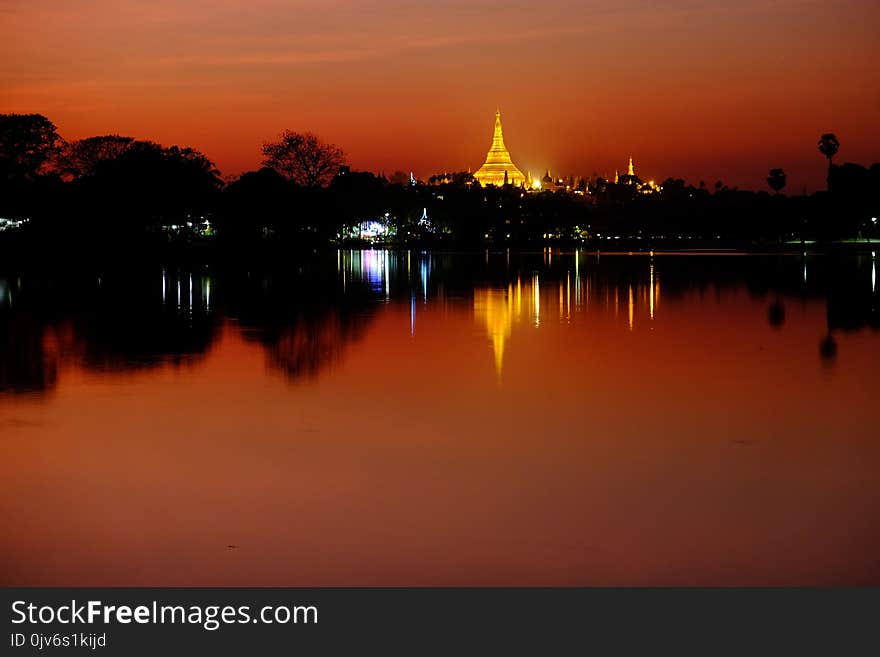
[0,114,63,180]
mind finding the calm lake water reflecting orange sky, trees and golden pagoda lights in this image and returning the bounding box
[0,250,880,585]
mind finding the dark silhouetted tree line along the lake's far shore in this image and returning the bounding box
[0,114,880,247]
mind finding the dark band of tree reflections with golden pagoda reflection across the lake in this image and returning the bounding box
[0,250,880,393]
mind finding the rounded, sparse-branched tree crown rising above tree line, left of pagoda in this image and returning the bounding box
[262,130,346,188]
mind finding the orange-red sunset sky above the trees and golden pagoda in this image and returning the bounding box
[0,0,880,192]
